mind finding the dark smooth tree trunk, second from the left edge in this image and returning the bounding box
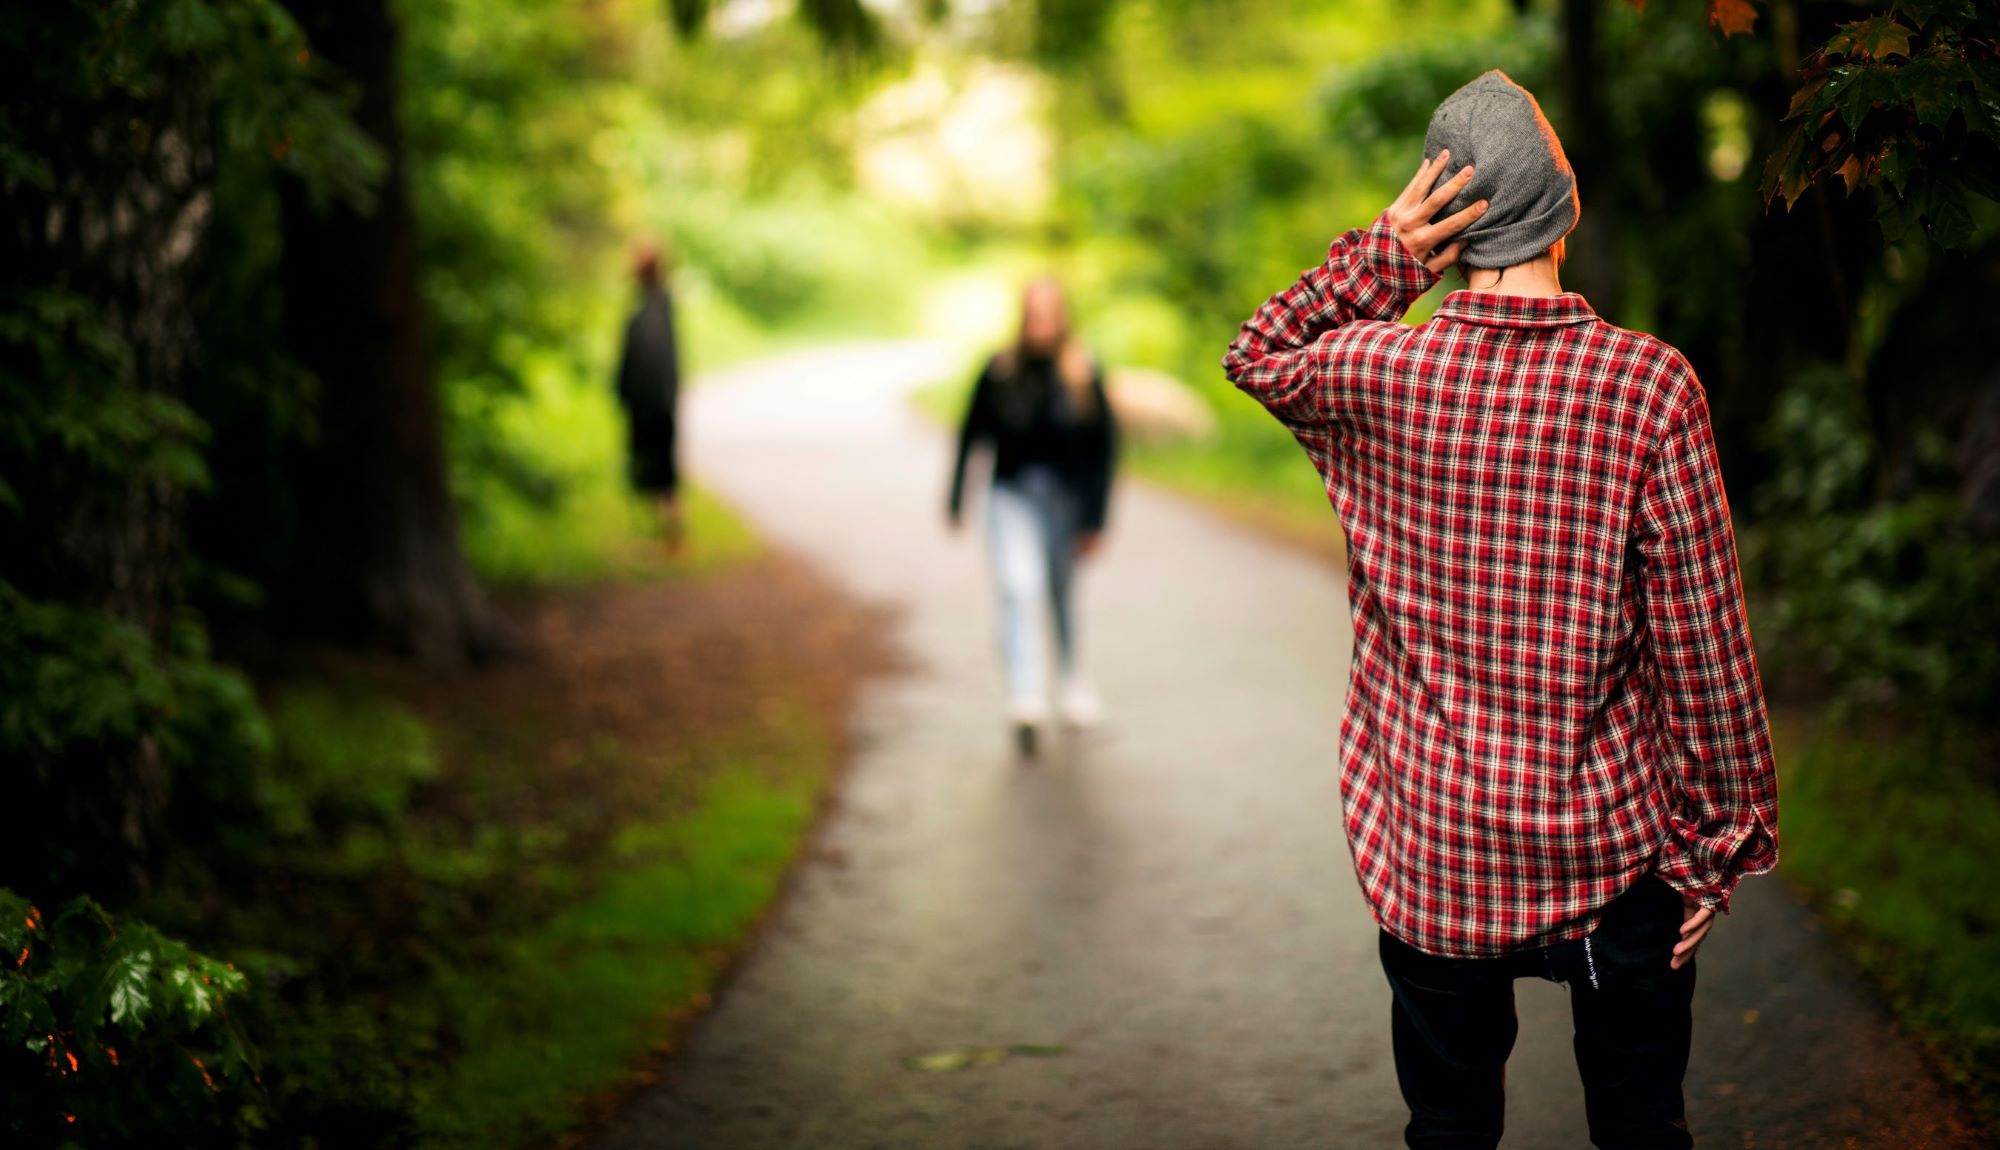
[280,0,504,666]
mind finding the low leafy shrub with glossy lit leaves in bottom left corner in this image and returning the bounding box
[0,888,262,1148]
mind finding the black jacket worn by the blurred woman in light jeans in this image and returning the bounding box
[950,356,1118,532]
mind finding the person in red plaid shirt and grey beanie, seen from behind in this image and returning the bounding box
[1222,72,1778,1148]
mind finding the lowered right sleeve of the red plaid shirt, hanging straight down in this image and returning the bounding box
[1636,392,1778,910]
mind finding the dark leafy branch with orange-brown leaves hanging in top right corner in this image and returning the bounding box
[1764,0,2000,248]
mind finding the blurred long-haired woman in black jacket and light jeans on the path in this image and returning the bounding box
[950,280,1118,754]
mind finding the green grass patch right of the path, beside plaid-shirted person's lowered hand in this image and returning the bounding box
[1778,716,2000,1124]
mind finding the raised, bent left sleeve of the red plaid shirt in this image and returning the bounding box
[1222,216,1438,428]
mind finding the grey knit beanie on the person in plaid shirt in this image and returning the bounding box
[1424,68,1580,268]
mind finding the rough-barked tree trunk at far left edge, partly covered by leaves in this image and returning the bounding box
[0,36,214,894]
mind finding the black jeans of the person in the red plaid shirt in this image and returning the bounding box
[1382,874,1694,1150]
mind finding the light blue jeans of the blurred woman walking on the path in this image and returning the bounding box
[986,468,1076,706]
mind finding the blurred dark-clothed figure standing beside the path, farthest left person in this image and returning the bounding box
[618,244,682,550]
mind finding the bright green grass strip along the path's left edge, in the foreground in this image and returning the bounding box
[424,730,828,1148]
